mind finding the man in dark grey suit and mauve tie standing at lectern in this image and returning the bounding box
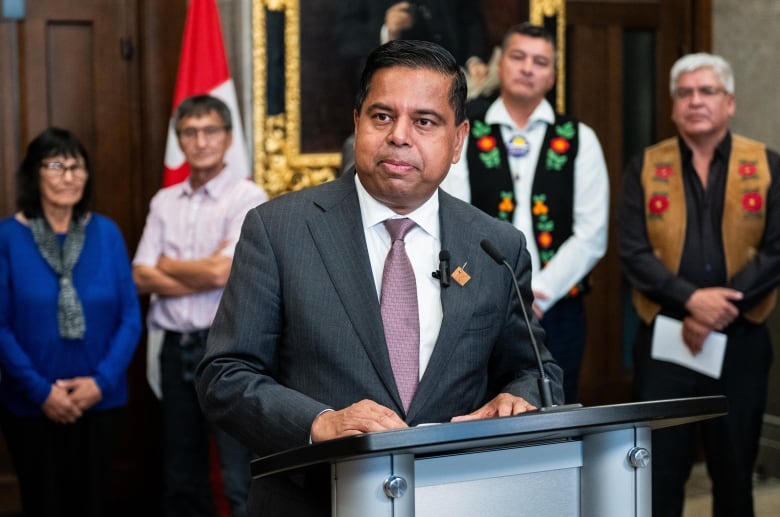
[197,40,563,516]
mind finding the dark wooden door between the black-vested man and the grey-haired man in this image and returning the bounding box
[566,0,711,405]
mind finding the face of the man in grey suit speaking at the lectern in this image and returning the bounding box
[354,67,468,214]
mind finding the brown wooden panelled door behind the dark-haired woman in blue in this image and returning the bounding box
[19,0,145,242]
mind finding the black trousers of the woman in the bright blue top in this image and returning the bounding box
[0,408,123,517]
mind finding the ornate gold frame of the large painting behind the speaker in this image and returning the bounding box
[252,0,566,197]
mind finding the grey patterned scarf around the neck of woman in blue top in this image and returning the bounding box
[30,217,86,339]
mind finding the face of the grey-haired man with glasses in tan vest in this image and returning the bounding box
[672,68,735,143]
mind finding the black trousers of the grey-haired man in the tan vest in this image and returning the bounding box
[634,322,772,517]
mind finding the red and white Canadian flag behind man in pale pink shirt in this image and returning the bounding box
[163,0,251,187]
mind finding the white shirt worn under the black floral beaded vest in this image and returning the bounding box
[441,98,609,311]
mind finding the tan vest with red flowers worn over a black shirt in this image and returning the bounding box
[633,135,777,325]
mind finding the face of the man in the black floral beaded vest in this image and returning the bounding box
[498,34,555,104]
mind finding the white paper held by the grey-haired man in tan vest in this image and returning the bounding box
[651,315,726,379]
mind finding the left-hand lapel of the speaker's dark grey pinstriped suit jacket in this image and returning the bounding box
[307,174,402,408]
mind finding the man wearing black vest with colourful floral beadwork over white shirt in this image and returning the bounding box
[442,23,609,403]
